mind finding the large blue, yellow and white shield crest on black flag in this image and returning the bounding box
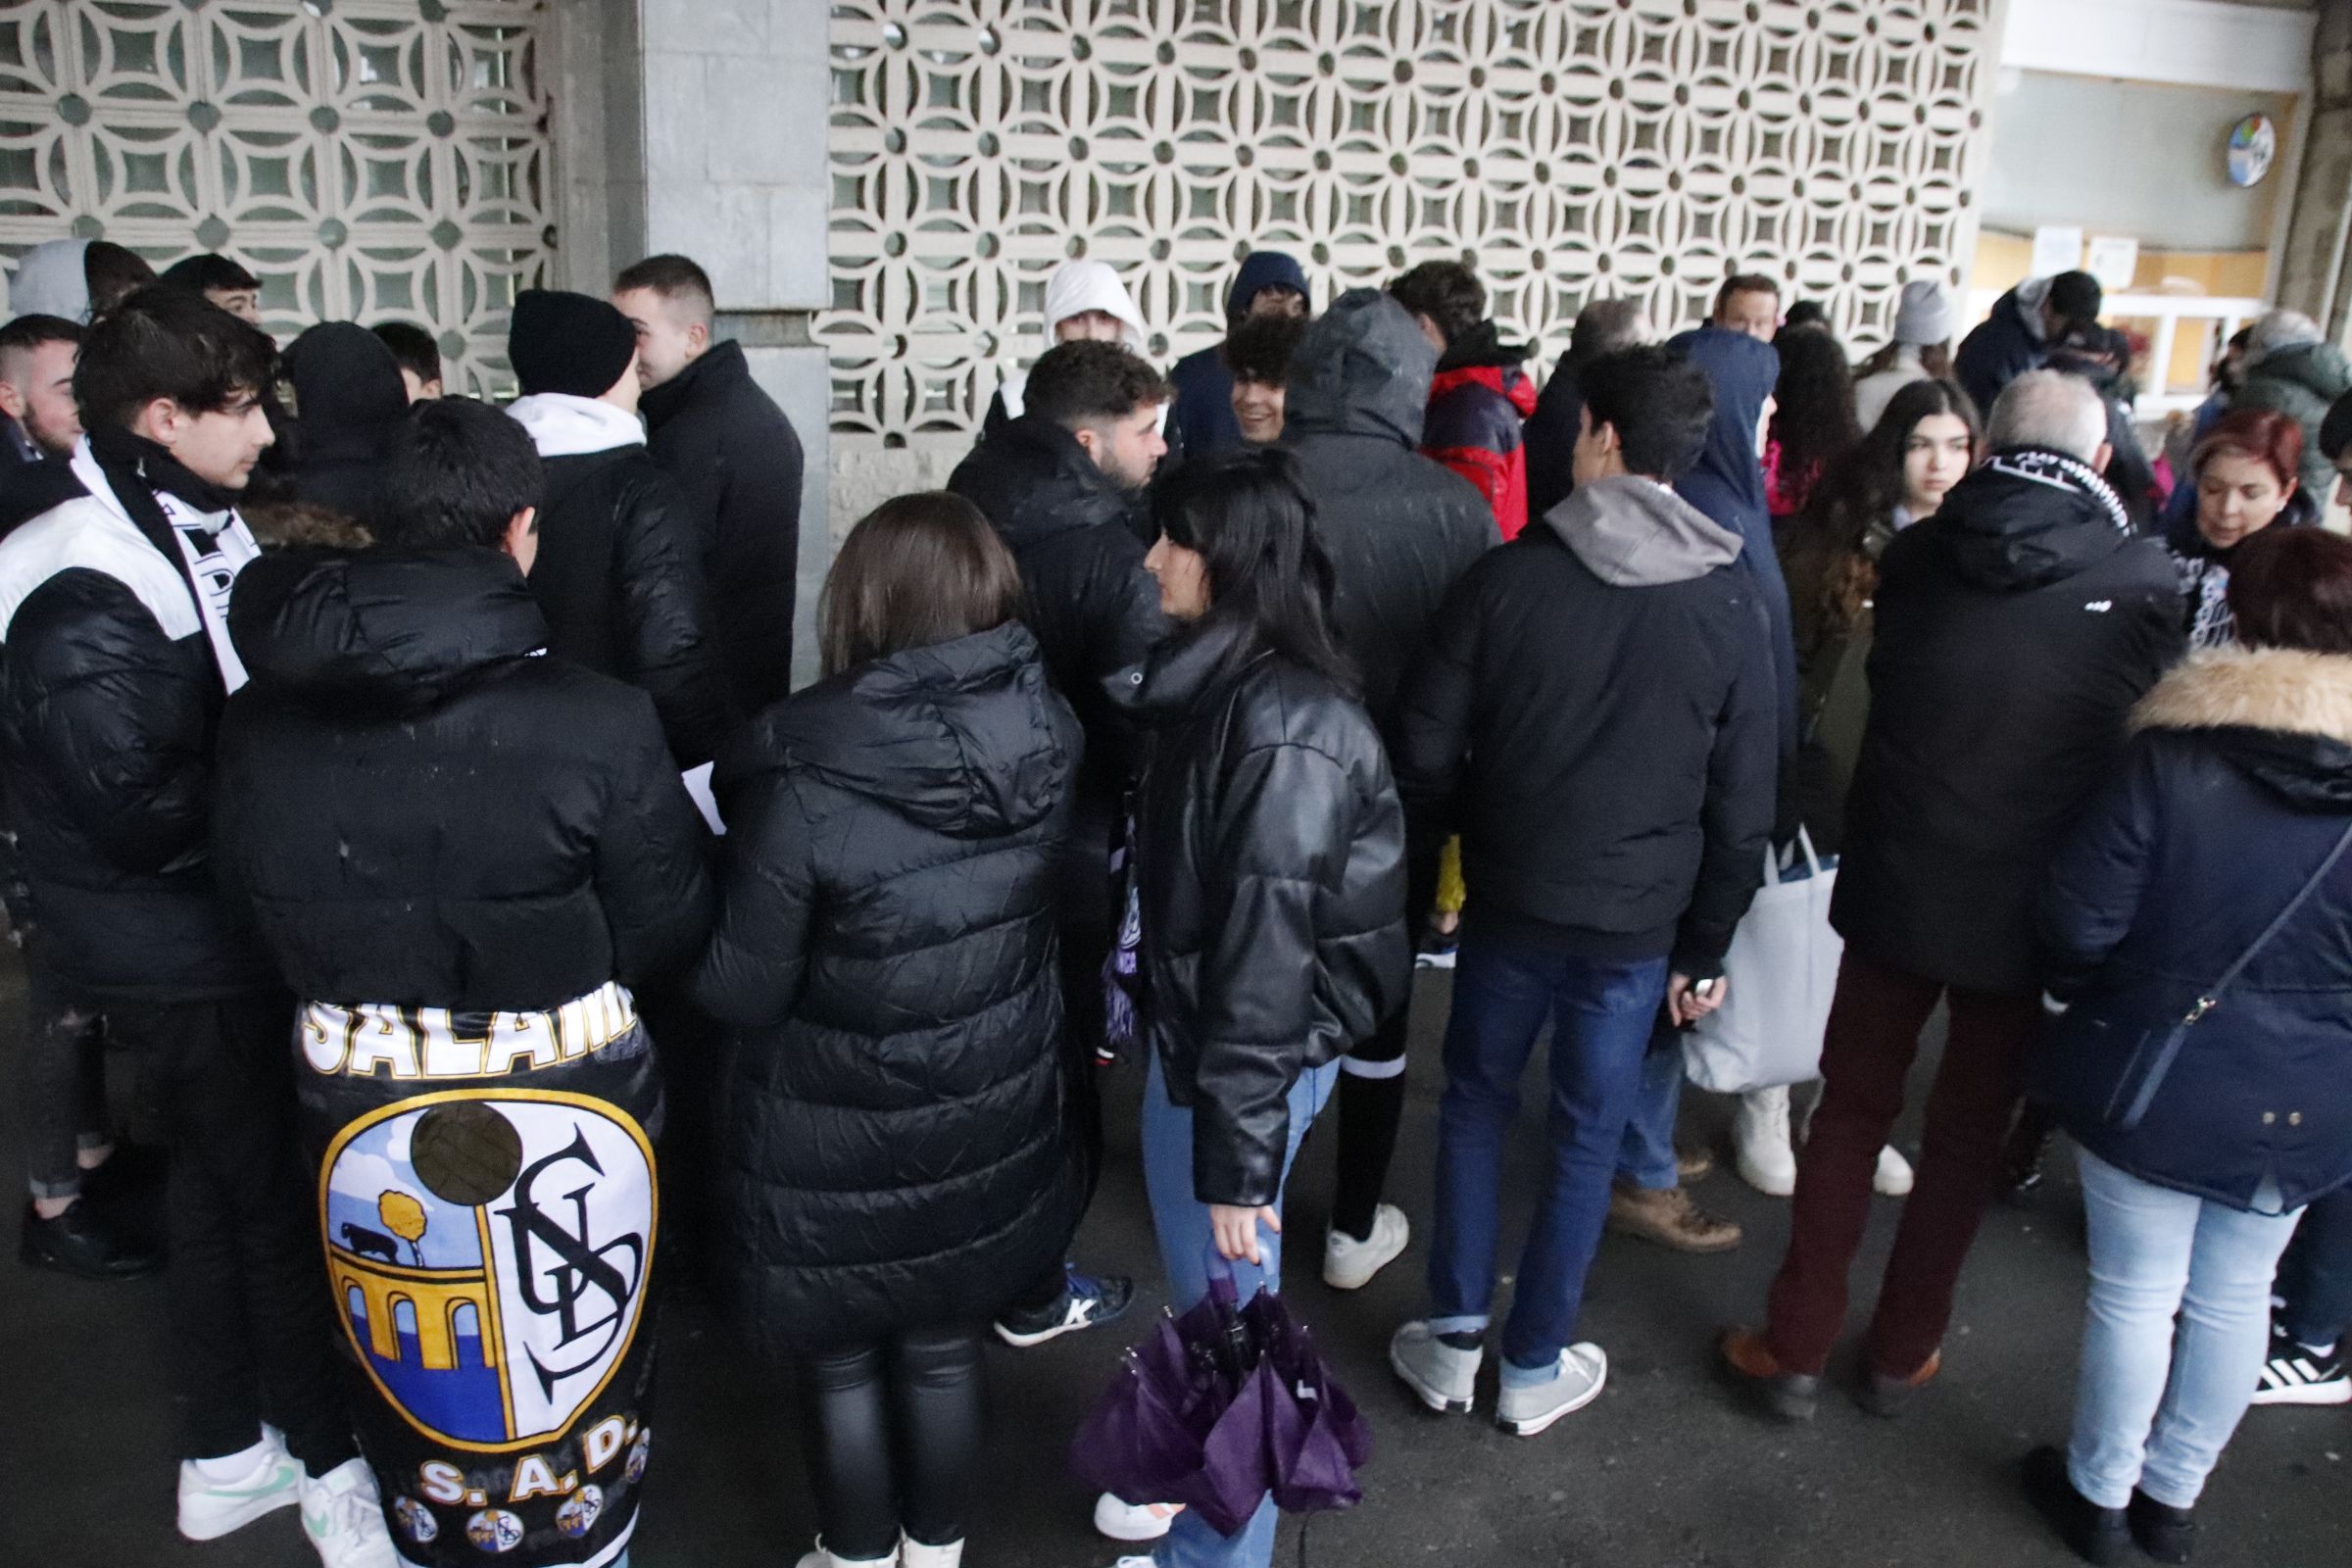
[319,1089,657,1447]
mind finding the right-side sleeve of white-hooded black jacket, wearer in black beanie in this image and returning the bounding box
[613,467,731,768]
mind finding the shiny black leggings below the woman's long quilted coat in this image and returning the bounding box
[800,1328,986,1561]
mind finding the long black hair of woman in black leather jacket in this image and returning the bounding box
[1154,447,1357,694]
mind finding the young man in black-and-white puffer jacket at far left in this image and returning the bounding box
[0,289,393,1568]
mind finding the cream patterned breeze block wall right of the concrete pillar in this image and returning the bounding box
[818,0,1994,461]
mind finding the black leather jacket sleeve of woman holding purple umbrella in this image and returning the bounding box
[1193,745,1357,1203]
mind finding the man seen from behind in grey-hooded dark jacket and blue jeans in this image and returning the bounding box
[1388,348,1776,1437]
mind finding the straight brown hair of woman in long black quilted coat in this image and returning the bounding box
[816,491,1021,674]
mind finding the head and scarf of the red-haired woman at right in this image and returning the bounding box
[2166,409,2319,649]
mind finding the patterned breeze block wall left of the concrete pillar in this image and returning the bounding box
[0,0,553,393]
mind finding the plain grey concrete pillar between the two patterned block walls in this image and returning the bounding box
[551,0,833,679]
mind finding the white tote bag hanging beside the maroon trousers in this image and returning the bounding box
[1682,830,1846,1093]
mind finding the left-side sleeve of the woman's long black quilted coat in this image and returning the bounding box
[692,771,816,1030]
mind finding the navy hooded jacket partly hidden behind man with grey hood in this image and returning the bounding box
[1668,322,1797,761]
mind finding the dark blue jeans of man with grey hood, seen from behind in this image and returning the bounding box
[1430,931,1682,1371]
